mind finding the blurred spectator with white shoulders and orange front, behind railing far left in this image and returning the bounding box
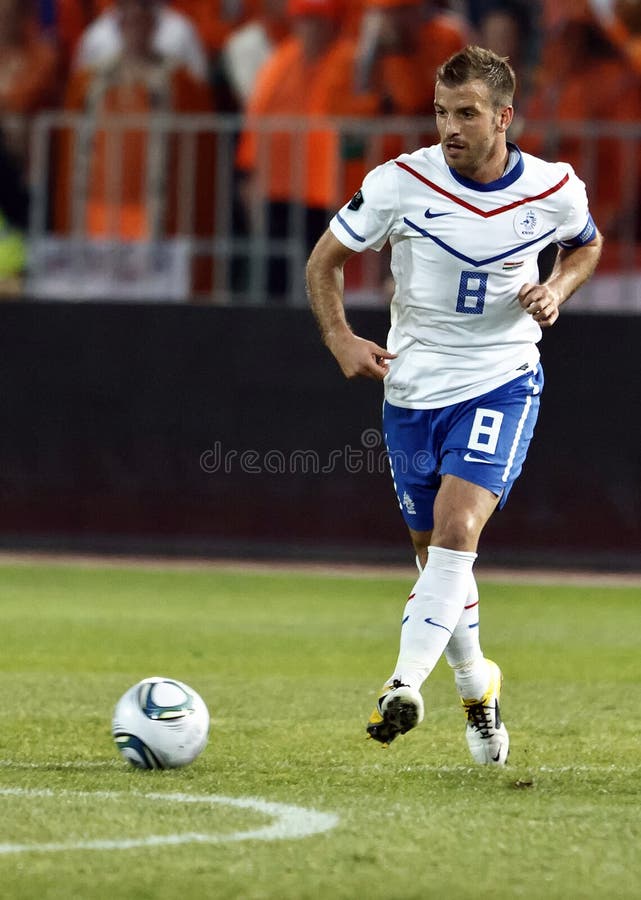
[55,0,215,290]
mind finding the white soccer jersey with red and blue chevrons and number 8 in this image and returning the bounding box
[330,144,596,409]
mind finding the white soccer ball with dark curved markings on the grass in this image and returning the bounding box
[111,676,209,769]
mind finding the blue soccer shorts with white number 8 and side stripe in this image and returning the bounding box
[383,365,543,531]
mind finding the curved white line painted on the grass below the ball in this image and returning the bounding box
[0,788,339,855]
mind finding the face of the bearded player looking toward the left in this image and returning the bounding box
[434,81,512,181]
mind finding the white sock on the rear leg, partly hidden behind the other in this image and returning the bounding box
[445,575,490,700]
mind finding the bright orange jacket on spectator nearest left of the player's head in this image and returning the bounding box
[237,37,376,208]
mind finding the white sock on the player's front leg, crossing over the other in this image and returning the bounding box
[389,547,476,688]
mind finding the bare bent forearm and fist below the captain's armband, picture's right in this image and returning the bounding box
[518,231,603,328]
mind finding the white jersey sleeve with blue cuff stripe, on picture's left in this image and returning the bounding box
[329,163,398,253]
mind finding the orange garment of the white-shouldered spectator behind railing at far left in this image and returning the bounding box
[56,63,213,240]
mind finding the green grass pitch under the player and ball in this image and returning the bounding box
[0,564,641,900]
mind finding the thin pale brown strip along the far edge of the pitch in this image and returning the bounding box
[0,552,641,588]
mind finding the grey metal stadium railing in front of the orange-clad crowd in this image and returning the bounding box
[5,111,641,313]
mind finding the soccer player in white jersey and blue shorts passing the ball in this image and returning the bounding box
[307,40,602,765]
